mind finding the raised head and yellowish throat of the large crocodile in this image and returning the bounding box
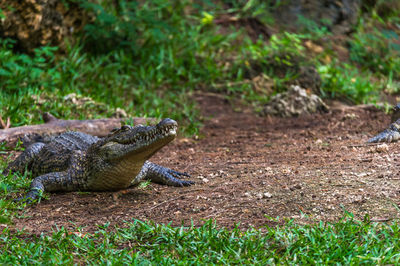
[86,118,178,190]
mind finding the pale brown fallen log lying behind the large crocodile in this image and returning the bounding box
[0,113,157,145]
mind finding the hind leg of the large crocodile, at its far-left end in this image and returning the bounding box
[2,142,45,176]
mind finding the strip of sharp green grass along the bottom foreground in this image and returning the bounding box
[0,216,400,265]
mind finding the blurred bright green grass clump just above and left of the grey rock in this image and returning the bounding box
[212,32,309,101]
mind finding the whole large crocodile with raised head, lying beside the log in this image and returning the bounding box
[2,118,194,202]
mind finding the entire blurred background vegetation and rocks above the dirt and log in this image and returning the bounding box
[0,0,400,134]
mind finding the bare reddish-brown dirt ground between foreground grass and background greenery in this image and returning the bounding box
[7,94,400,233]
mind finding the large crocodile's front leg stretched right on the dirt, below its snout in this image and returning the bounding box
[132,161,194,187]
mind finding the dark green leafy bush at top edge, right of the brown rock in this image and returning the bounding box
[79,0,174,54]
